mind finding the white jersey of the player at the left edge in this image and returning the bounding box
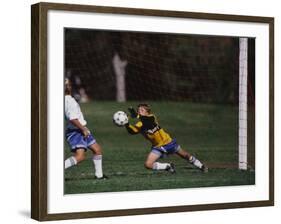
[64,95,87,129]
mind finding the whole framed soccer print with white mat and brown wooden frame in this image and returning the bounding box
[31,3,274,221]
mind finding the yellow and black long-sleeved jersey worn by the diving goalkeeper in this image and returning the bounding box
[126,114,172,147]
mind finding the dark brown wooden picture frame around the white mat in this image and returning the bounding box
[31,3,274,221]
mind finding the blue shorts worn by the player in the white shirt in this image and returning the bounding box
[66,129,96,152]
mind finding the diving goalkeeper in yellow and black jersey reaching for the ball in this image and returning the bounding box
[125,103,208,173]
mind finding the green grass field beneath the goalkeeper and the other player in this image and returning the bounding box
[64,102,255,194]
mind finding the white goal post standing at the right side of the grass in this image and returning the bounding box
[239,37,248,170]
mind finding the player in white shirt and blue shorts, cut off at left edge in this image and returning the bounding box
[64,78,107,179]
